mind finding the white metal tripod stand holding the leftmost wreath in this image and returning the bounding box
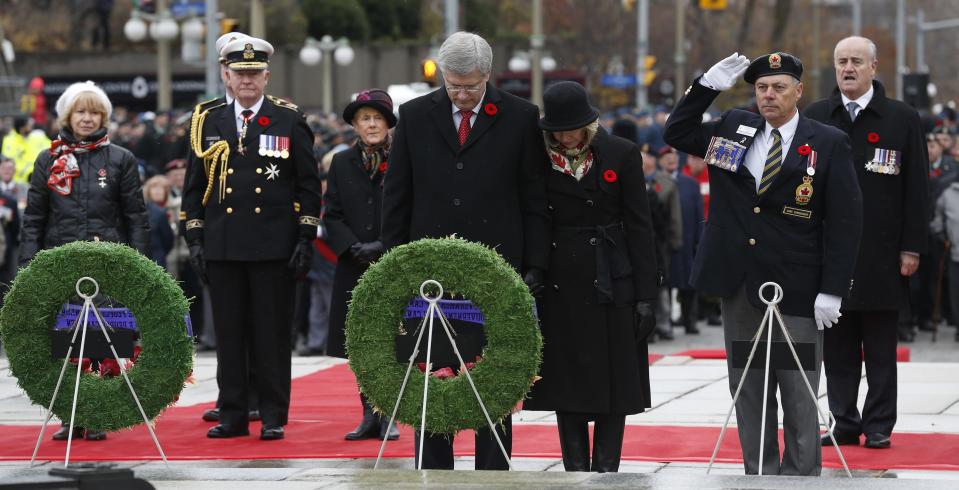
[30,277,168,468]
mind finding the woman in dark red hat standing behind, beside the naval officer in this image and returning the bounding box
[323,89,400,441]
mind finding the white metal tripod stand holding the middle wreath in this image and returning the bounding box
[373,279,513,470]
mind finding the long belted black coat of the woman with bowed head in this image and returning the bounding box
[524,129,657,414]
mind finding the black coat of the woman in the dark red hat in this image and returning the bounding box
[323,146,383,358]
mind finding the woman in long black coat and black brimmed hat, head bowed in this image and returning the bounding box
[524,82,657,472]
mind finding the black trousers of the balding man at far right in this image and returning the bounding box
[823,310,899,435]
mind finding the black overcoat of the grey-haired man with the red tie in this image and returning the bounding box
[382,83,549,273]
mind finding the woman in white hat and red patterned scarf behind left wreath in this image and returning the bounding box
[20,82,148,440]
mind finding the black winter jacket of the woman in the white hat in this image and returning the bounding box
[20,134,149,262]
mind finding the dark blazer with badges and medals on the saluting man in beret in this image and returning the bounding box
[665,79,862,317]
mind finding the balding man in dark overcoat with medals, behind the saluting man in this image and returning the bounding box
[806,36,929,448]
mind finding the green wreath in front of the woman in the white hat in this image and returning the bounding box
[0,242,193,431]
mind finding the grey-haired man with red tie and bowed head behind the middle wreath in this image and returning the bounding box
[382,32,548,470]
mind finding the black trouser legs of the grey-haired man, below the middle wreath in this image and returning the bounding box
[413,415,513,470]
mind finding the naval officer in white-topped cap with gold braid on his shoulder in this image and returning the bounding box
[181,37,320,440]
